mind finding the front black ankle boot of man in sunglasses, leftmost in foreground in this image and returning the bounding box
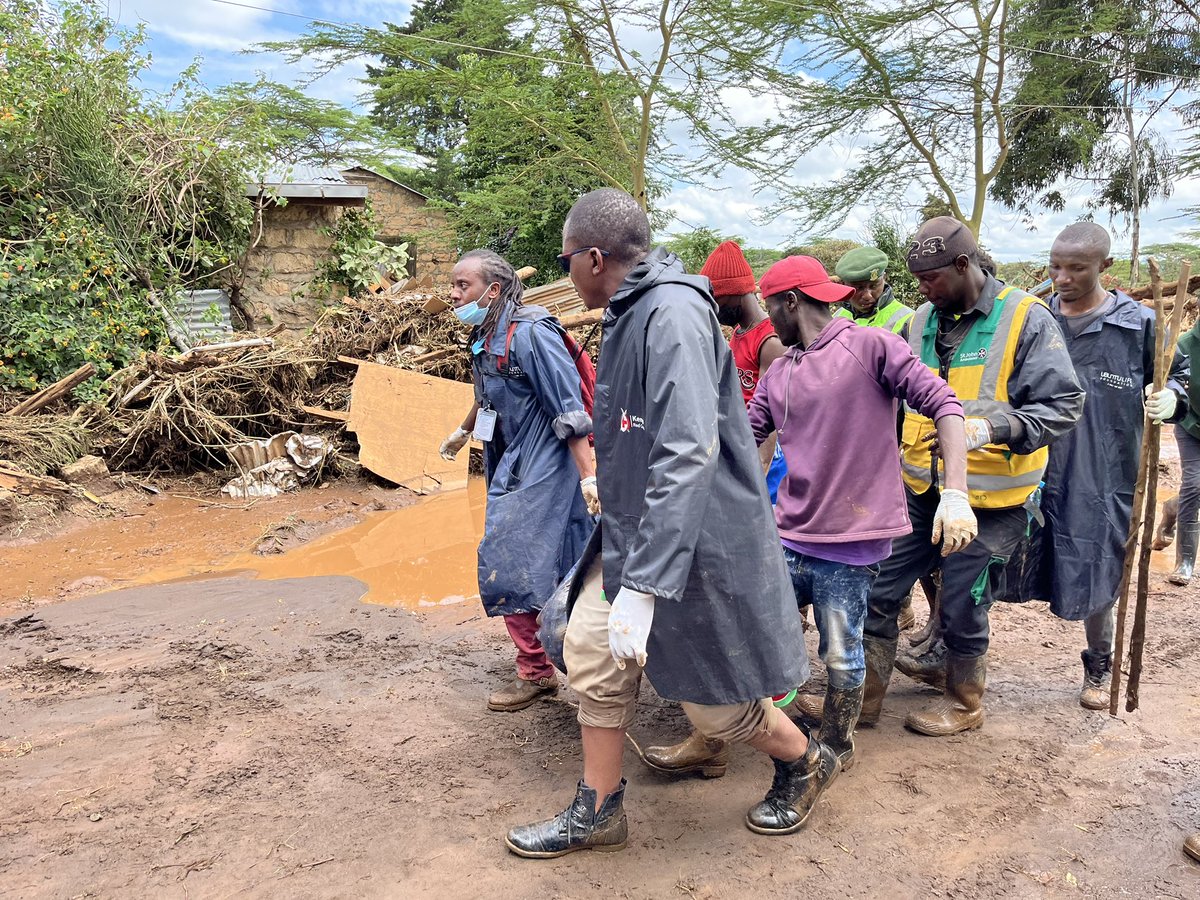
[504,779,629,859]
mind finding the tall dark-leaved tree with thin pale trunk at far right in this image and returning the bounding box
[991,0,1200,280]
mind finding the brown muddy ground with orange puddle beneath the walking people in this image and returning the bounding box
[0,475,1200,898]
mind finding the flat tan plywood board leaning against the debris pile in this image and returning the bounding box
[346,362,475,493]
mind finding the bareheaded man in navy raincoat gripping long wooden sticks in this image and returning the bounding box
[1039,222,1187,709]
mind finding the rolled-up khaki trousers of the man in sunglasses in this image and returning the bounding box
[563,557,784,742]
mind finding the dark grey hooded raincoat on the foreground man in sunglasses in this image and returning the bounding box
[594,248,809,706]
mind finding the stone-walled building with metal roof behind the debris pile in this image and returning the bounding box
[232,167,457,336]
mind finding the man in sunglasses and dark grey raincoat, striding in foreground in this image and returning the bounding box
[505,188,838,858]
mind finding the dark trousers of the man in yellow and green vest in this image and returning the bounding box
[863,488,1027,656]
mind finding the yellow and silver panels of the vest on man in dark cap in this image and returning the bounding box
[900,287,1050,509]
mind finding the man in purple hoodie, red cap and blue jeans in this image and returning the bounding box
[750,257,978,769]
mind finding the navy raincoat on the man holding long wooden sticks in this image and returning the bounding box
[1038,292,1187,620]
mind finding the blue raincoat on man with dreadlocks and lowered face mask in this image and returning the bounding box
[470,306,593,616]
